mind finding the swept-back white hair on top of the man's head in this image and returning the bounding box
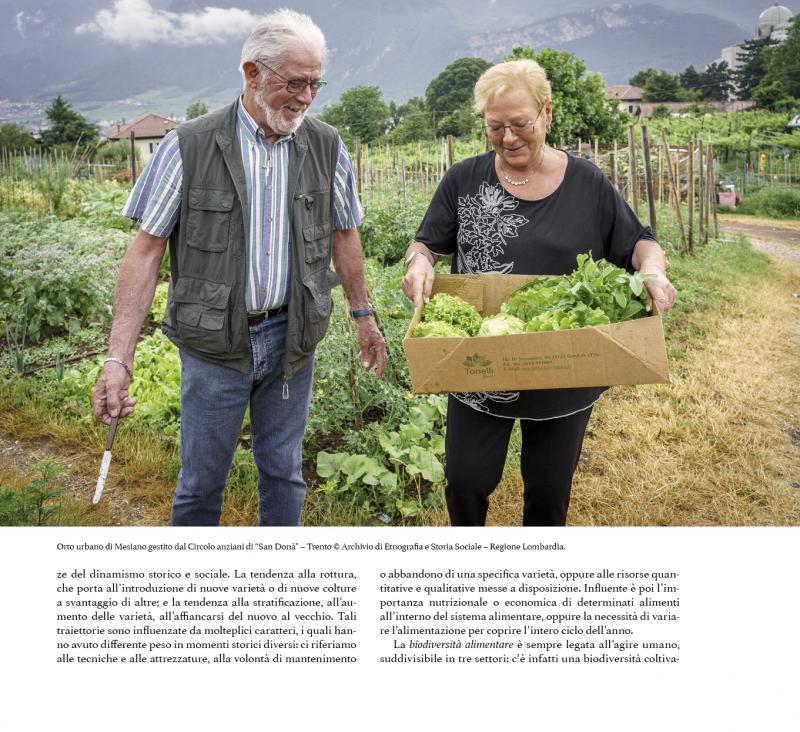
[239,8,328,85]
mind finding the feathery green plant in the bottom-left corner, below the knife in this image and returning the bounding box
[0,458,64,526]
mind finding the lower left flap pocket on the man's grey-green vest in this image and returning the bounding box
[173,277,231,354]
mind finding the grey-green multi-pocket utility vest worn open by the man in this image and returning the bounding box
[163,103,341,383]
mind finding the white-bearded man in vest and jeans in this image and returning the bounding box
[92,10,387,526]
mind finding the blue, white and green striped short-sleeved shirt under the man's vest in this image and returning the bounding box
[122,101,363,312]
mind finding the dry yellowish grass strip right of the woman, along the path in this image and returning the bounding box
[489,239,800,526]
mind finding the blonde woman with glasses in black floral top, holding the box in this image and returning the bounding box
[402,60,675,526]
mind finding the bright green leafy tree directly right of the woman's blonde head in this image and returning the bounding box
[503,46,627,142]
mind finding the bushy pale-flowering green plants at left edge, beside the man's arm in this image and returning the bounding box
[0,212,128,342]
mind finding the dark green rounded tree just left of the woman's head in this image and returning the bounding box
[425,57,491,135]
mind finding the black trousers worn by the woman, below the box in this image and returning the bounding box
[445,396,592,526]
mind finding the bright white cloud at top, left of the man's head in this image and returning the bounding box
[75,0,261,46]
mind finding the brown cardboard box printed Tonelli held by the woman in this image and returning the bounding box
[403,274,669,394]
